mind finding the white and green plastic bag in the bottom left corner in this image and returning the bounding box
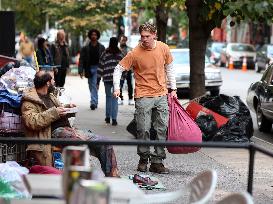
[0,161,31,199]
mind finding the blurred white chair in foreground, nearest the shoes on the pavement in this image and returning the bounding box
[130,170,217,204]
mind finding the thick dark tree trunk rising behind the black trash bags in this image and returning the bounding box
[186,0,210,99]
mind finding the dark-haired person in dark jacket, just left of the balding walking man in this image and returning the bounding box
[36,37,54,66]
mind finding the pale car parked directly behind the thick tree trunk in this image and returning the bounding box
[171,49,222,96]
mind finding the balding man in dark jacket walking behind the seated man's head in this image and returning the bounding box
[51,30,69,87]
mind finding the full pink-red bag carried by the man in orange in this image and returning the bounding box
[167,94,202,154]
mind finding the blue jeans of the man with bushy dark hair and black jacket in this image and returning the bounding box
[88,65,98,106]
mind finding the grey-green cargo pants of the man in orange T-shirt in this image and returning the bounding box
[135,96,169,163]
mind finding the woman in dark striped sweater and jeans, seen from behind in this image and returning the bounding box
[97,37,124,126]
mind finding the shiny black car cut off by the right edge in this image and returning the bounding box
[246,65,273,132]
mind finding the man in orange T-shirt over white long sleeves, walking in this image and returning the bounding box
[113,23,177,174]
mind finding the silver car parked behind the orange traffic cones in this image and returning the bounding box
[220,43,256,69]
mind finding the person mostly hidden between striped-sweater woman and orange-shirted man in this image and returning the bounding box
[119,35,135,105]
